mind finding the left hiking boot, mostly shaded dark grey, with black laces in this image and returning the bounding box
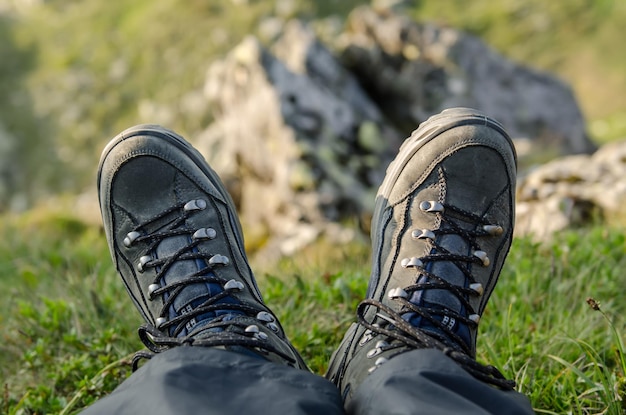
[98,125,306,369]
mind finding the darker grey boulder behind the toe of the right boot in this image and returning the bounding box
[339,7,595,156]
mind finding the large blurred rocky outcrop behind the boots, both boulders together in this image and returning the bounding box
[194,8,593,256]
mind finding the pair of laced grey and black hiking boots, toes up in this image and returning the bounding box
[98,108,516,406]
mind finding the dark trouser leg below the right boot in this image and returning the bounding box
[346,349,534,415]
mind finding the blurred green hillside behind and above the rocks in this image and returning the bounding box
[0,0,626,211]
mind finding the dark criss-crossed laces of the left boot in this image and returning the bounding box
[124,199,295,371]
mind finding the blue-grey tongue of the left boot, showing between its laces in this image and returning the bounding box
[155,235,237,337]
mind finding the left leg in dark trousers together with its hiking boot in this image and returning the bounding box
[87,125,342,415]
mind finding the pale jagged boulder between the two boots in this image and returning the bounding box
[194,23,401,255]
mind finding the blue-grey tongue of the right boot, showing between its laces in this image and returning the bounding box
[402,235,470,345]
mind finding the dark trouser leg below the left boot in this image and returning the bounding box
[84,347,344,415]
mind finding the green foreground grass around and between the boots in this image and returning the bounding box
[0,211,626,414]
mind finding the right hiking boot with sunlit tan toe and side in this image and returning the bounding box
[327,108,516,404]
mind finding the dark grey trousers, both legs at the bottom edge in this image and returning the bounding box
[83,347,534,415]
